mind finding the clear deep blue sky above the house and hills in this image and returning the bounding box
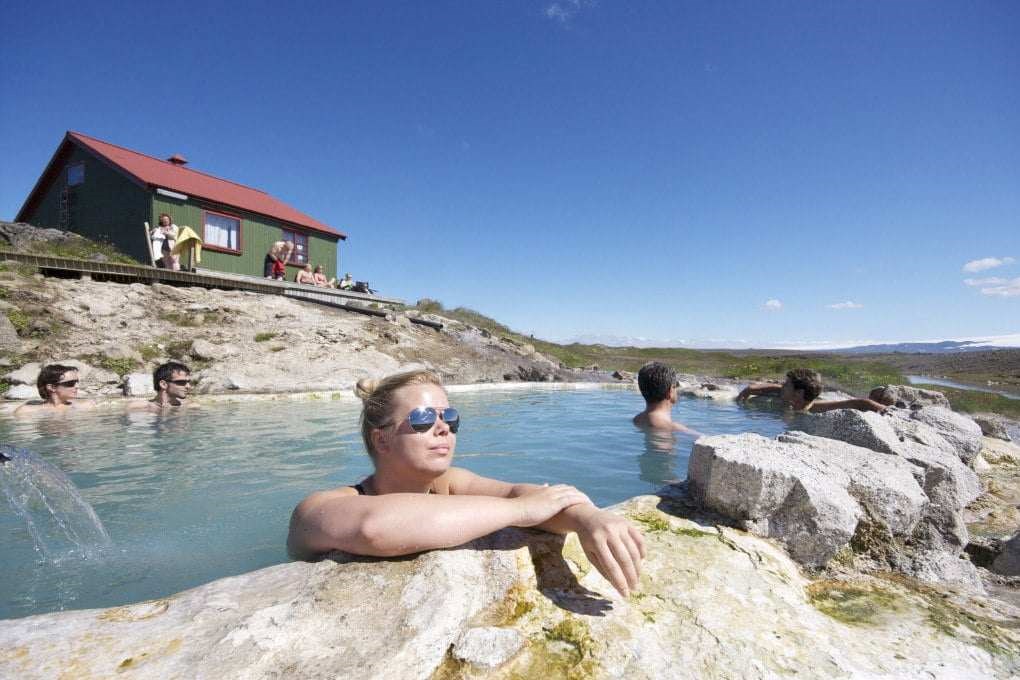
[0,0,1020,346]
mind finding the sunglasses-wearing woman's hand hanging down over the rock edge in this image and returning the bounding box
[577,510,645,597]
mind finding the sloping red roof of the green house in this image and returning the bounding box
[57,132,347,239]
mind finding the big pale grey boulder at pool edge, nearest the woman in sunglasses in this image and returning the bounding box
[687,432,928,567]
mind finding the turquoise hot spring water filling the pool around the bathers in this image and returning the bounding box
[0,387,786,619]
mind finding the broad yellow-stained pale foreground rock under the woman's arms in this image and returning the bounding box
[0,496,1020,680]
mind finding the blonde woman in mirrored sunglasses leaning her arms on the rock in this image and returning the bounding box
[287,370,645,596]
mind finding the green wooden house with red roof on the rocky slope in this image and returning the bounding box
[16,132,347,280]
